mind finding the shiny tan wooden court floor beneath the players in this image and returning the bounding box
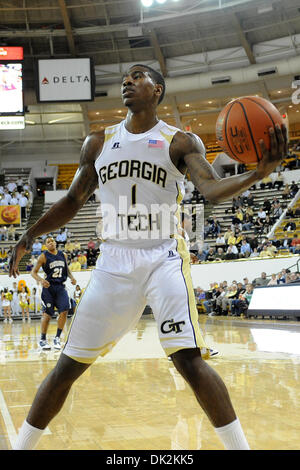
[0,316,300,450]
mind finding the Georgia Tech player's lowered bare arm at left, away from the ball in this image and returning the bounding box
[9,132,104,277]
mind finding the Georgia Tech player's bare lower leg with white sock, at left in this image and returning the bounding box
[13,354,90,450]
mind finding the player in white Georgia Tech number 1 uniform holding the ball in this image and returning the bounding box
[10,65,287,449]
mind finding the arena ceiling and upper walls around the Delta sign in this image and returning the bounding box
[0,0,300,151]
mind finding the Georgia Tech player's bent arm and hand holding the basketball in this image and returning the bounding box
[181,126,288,203]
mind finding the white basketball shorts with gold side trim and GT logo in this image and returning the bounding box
[63,238,206,363]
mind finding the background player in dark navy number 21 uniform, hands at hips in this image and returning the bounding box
[31,237,76,350]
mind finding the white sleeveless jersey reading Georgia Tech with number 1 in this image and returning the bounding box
[95,121,184,248]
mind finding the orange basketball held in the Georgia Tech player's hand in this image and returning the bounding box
[216,96,283,163]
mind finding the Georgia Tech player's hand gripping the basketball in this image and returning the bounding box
[256,124,288,179]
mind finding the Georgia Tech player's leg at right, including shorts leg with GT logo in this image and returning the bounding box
[148,241,249,449]
